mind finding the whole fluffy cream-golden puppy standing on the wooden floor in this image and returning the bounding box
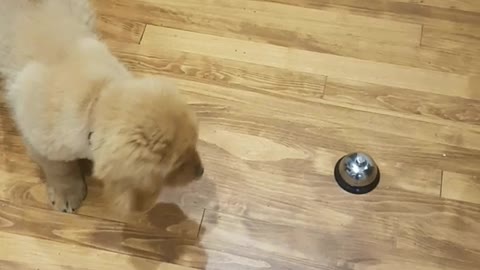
[0,0,203,213]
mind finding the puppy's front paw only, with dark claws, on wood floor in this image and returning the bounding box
[47,181,87,213]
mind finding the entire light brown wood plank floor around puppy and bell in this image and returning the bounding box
[0,0,480,270]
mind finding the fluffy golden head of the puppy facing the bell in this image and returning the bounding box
[90,78,204,215]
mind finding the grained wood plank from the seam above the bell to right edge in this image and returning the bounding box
[324,77,480,125]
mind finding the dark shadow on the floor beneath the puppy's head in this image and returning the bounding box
[80,160,208,270]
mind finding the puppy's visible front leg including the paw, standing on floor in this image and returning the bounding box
[30,144,87,213]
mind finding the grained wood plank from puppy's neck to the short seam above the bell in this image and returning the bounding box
[108,42,326,103]
